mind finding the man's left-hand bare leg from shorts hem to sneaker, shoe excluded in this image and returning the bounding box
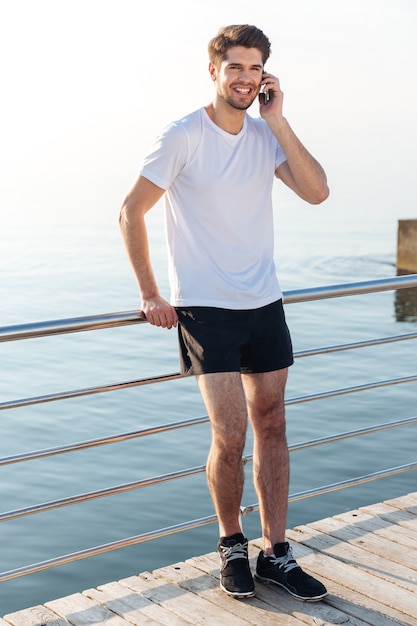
[197,372,247,537]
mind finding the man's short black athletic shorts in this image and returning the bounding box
[176,300,294,375]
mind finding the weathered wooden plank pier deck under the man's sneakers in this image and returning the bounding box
[0,493,417,626]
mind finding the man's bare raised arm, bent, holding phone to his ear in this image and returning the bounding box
[260,74,329,204]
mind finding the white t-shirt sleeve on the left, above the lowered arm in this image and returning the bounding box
[140,122,188,189]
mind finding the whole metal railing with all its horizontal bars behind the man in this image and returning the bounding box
[0,274,417,582]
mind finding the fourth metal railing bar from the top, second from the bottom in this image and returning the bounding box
[0,416,417,522]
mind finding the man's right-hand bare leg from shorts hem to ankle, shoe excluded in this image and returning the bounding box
[242,369,289,554]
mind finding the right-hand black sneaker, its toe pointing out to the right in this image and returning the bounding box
[255,541,327,602]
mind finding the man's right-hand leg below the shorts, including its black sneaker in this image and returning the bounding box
[242,369,327,602]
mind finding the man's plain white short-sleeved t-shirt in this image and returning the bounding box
[140,108,285,309]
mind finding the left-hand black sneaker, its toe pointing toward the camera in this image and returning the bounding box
[217,533,255,598]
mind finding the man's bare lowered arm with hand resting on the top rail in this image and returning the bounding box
[119,176,178,328]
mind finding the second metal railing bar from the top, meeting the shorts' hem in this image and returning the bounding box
[0,333,417,411]
